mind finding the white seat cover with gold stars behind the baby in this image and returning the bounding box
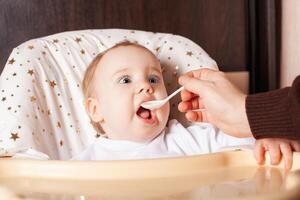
[0,29,217,160]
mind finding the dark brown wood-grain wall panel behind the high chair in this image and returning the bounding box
[0,0,248,71]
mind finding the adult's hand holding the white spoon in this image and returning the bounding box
[178,69,252,137]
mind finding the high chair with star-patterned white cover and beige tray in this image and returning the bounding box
[0,29,300,199]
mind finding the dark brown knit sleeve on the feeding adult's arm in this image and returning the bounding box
[246,76,300,140]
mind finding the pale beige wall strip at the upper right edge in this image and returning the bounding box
[280,0,300,87]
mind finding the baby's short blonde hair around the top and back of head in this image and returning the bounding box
[82,40,155,135]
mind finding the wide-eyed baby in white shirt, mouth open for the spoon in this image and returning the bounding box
[73,41,292,169]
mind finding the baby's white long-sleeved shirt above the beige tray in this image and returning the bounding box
[73,120,255,160]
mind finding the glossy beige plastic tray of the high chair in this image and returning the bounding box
[0,151,300,200]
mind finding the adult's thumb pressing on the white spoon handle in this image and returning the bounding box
[178,76,210,96]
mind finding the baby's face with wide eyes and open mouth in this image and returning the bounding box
[93,46,170,141]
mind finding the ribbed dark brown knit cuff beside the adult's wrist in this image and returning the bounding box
[246,88,295,139]
